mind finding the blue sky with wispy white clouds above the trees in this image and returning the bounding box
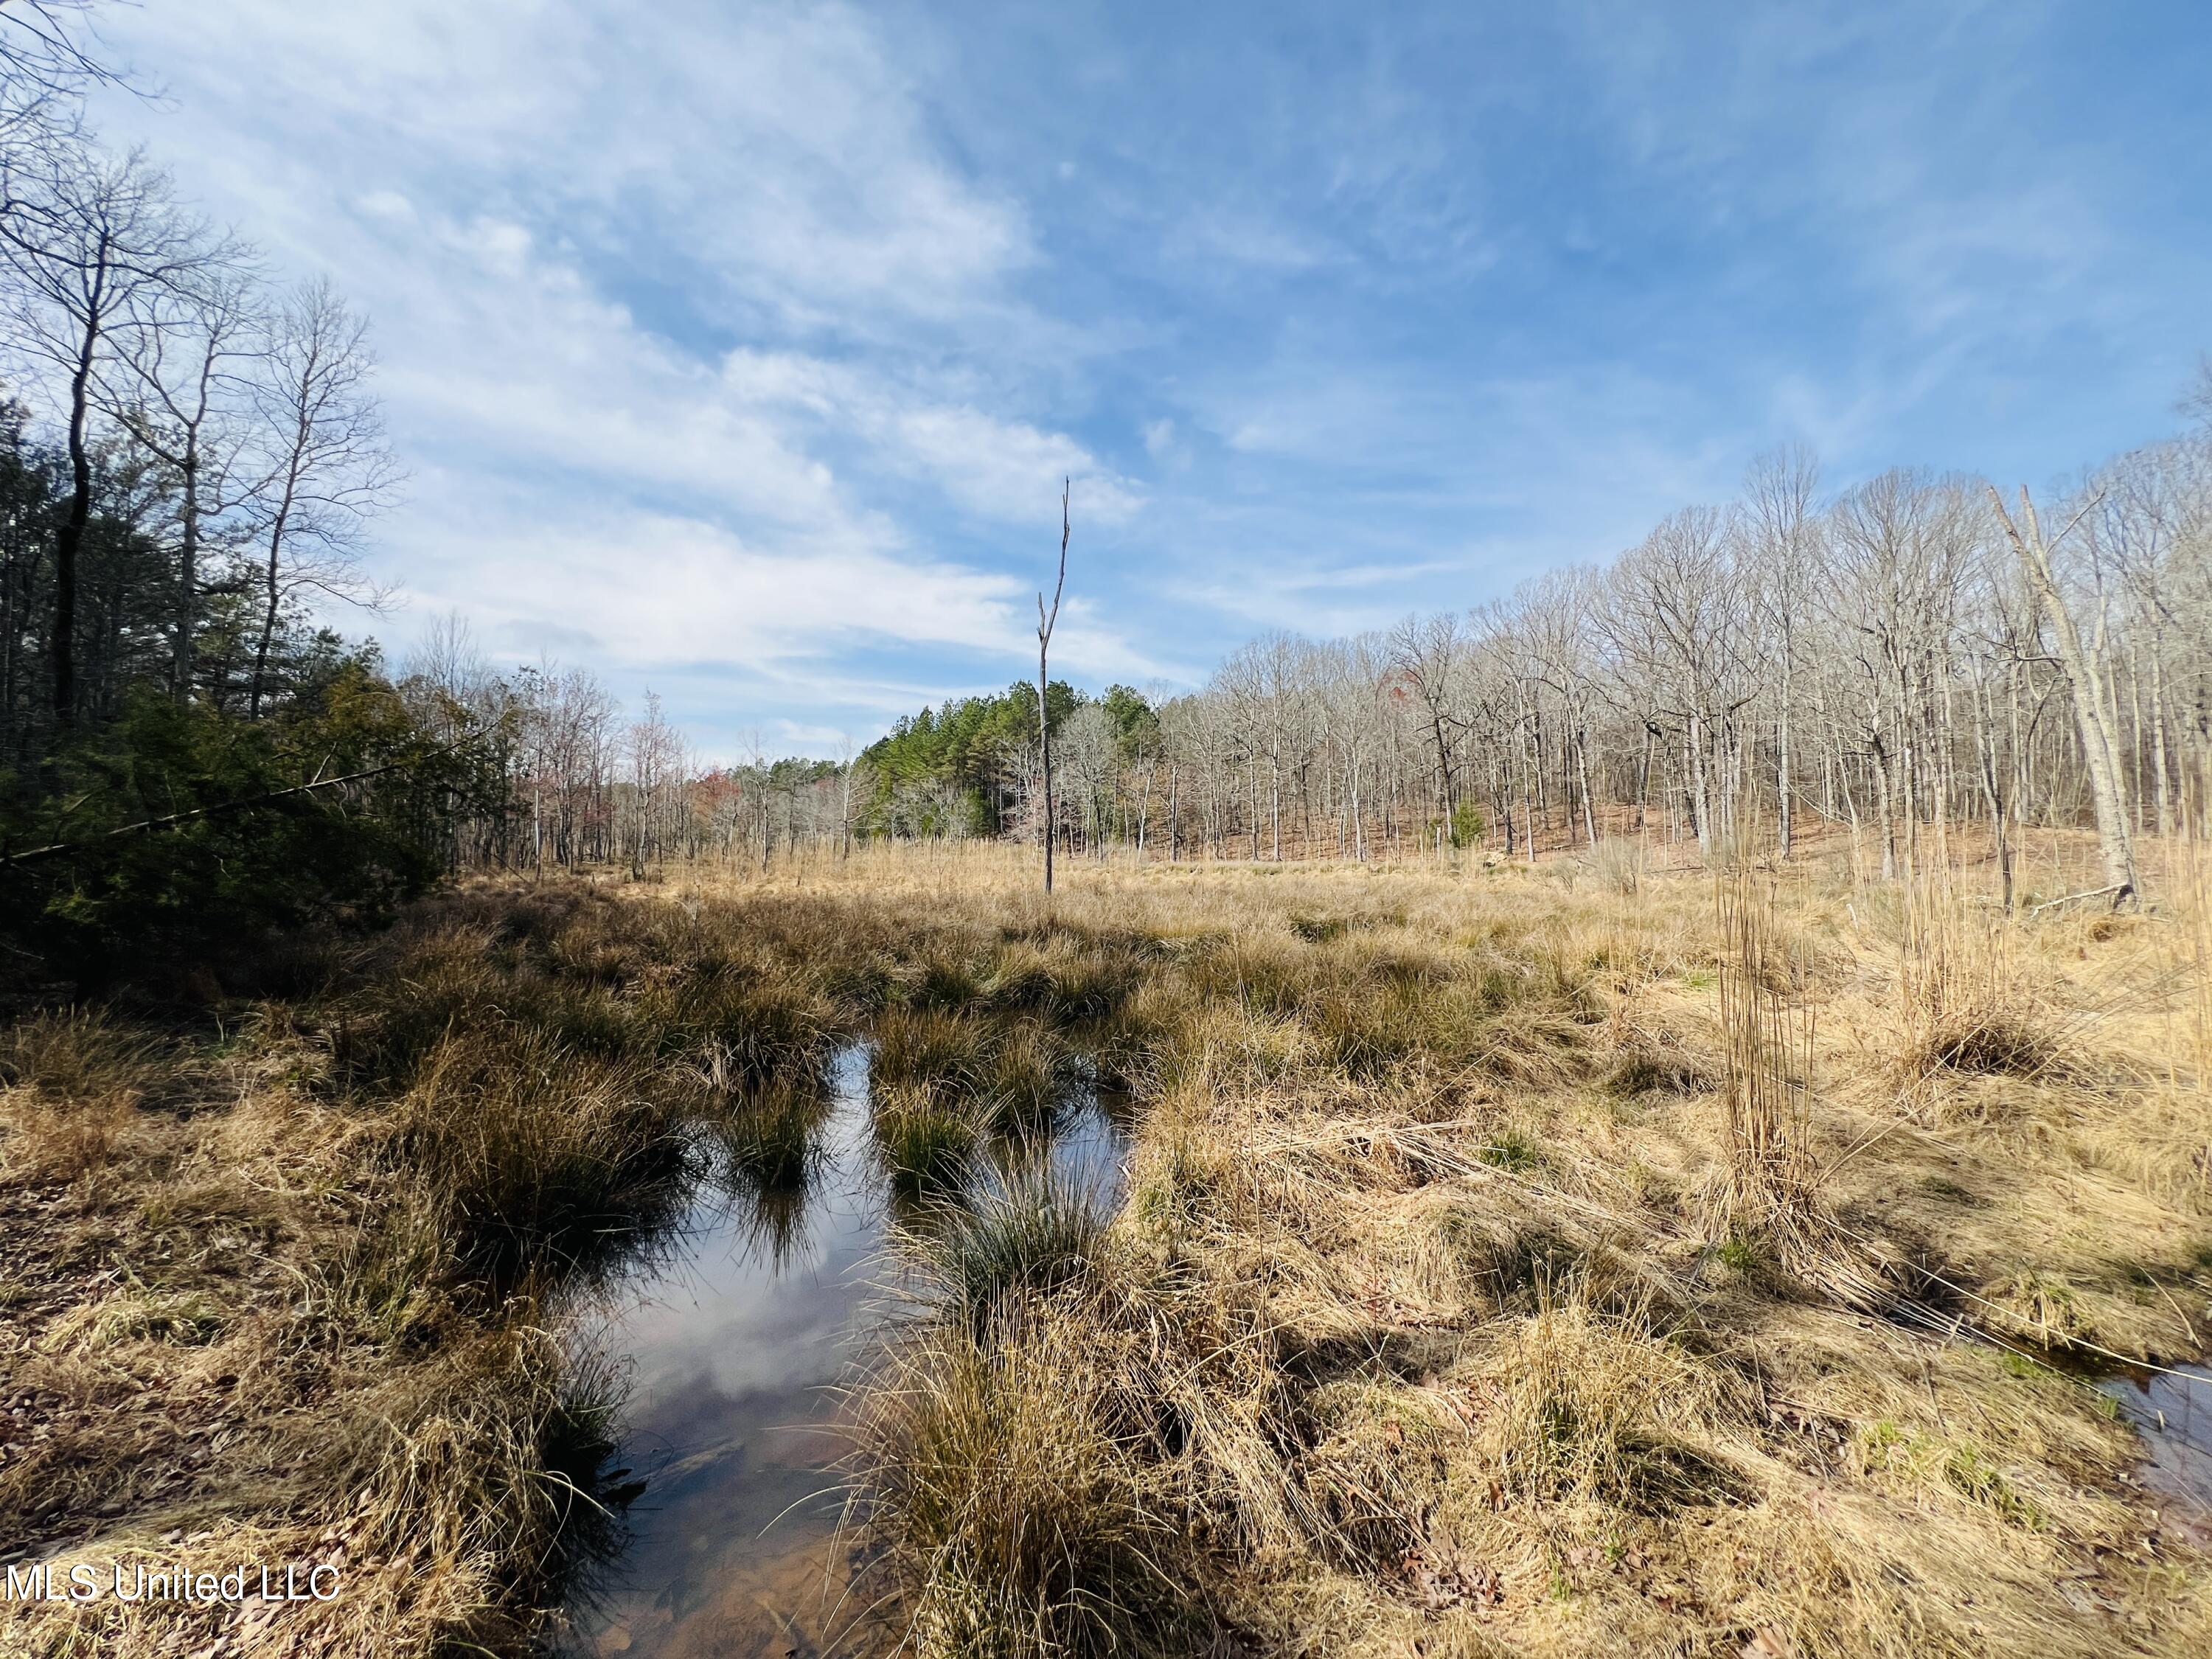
[82,0,2212,757]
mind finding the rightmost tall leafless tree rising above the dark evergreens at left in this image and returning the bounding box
[246,279,400,714]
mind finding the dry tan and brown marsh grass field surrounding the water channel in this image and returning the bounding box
[0,847,2212,1659]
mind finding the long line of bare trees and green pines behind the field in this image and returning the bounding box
[841,416,2212,916]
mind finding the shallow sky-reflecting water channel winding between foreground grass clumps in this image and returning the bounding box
[560,1044,1124,1659]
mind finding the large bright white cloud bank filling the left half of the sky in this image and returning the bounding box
[80,0,1146,743]
